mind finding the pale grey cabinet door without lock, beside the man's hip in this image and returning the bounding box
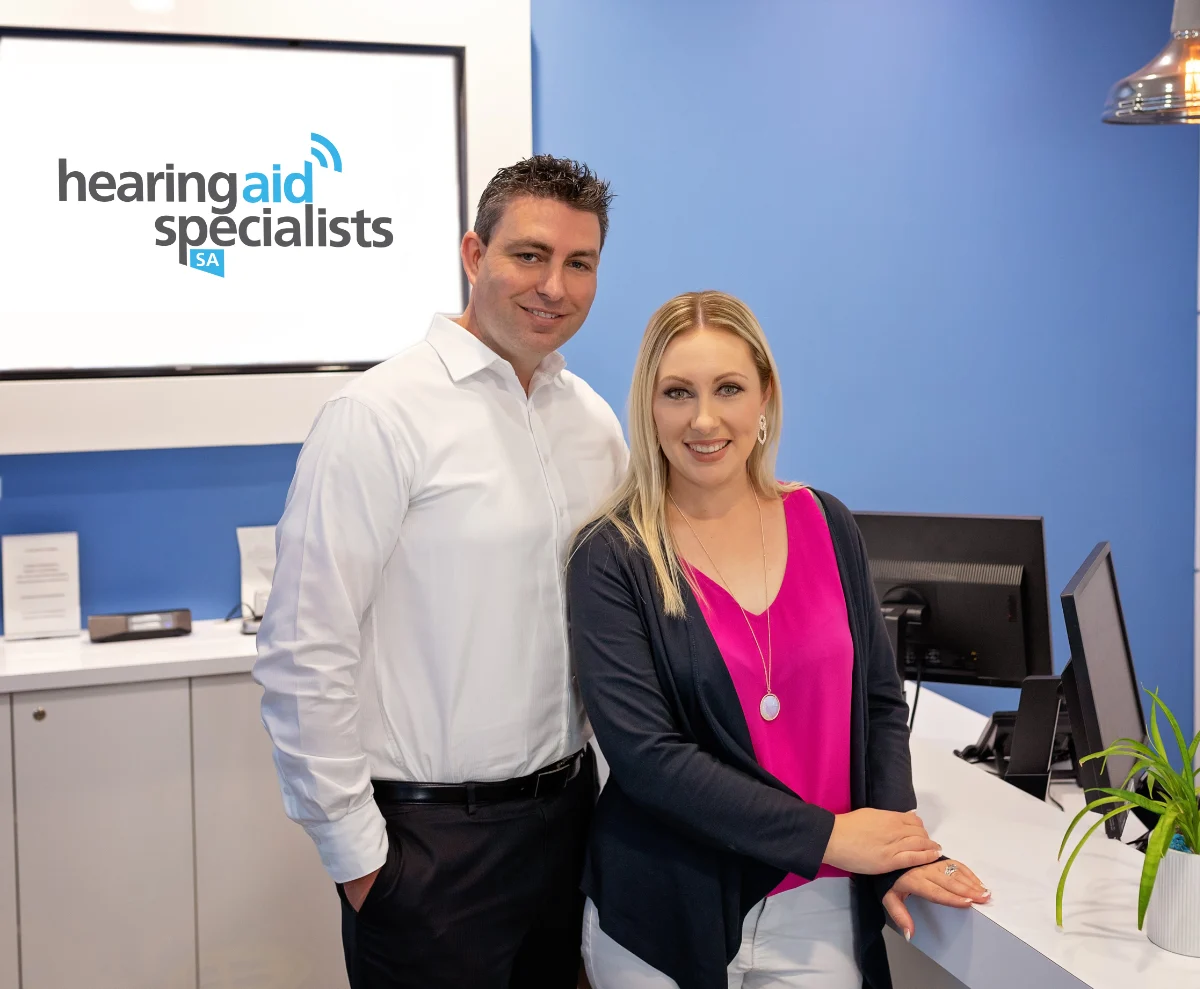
[192,675,347,989]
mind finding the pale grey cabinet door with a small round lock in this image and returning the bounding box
[12,681,196,989]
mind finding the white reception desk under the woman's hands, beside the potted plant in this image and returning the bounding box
[908,684,1200,989]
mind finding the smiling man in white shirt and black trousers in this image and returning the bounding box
[254,155,626,989]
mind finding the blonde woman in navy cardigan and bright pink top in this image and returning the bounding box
[569,292,988,989]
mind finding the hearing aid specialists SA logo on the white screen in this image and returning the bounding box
[59,133,392,278]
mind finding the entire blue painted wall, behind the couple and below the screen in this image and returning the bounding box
[0,0,1200,739]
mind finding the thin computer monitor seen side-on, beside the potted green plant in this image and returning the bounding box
[1062,543,1146,838]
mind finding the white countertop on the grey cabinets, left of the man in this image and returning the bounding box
[0,621,254,694]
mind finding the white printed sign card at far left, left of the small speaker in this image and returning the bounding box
[0,532,83,639]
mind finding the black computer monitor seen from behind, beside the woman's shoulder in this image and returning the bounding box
[854,511,1051,687]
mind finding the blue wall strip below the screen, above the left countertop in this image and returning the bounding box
[0,445,300,633]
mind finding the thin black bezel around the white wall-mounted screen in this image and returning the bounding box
[0,25,470,382]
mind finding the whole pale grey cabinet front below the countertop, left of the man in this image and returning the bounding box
[0,673,347,989]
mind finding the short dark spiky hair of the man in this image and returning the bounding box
[475,155,612,247]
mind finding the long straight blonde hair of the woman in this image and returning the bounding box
[576,292,802,618]
